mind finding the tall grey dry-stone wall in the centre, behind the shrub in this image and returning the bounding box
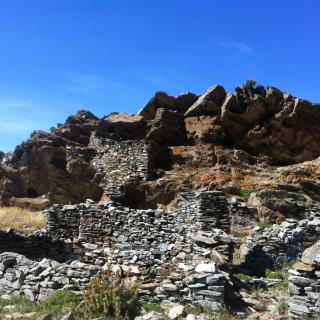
[42,191,233,308]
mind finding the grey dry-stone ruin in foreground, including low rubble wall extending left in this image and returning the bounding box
[0,191,233,309]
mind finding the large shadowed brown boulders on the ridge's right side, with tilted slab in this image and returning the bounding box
[185,86,320,164]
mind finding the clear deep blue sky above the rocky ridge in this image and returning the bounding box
[0,0,320,151]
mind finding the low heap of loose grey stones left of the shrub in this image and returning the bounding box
[0,252,98,302]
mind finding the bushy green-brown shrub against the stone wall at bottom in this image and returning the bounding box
[82,270,138,320]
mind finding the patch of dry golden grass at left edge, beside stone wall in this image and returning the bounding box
[0,207,45,233]
